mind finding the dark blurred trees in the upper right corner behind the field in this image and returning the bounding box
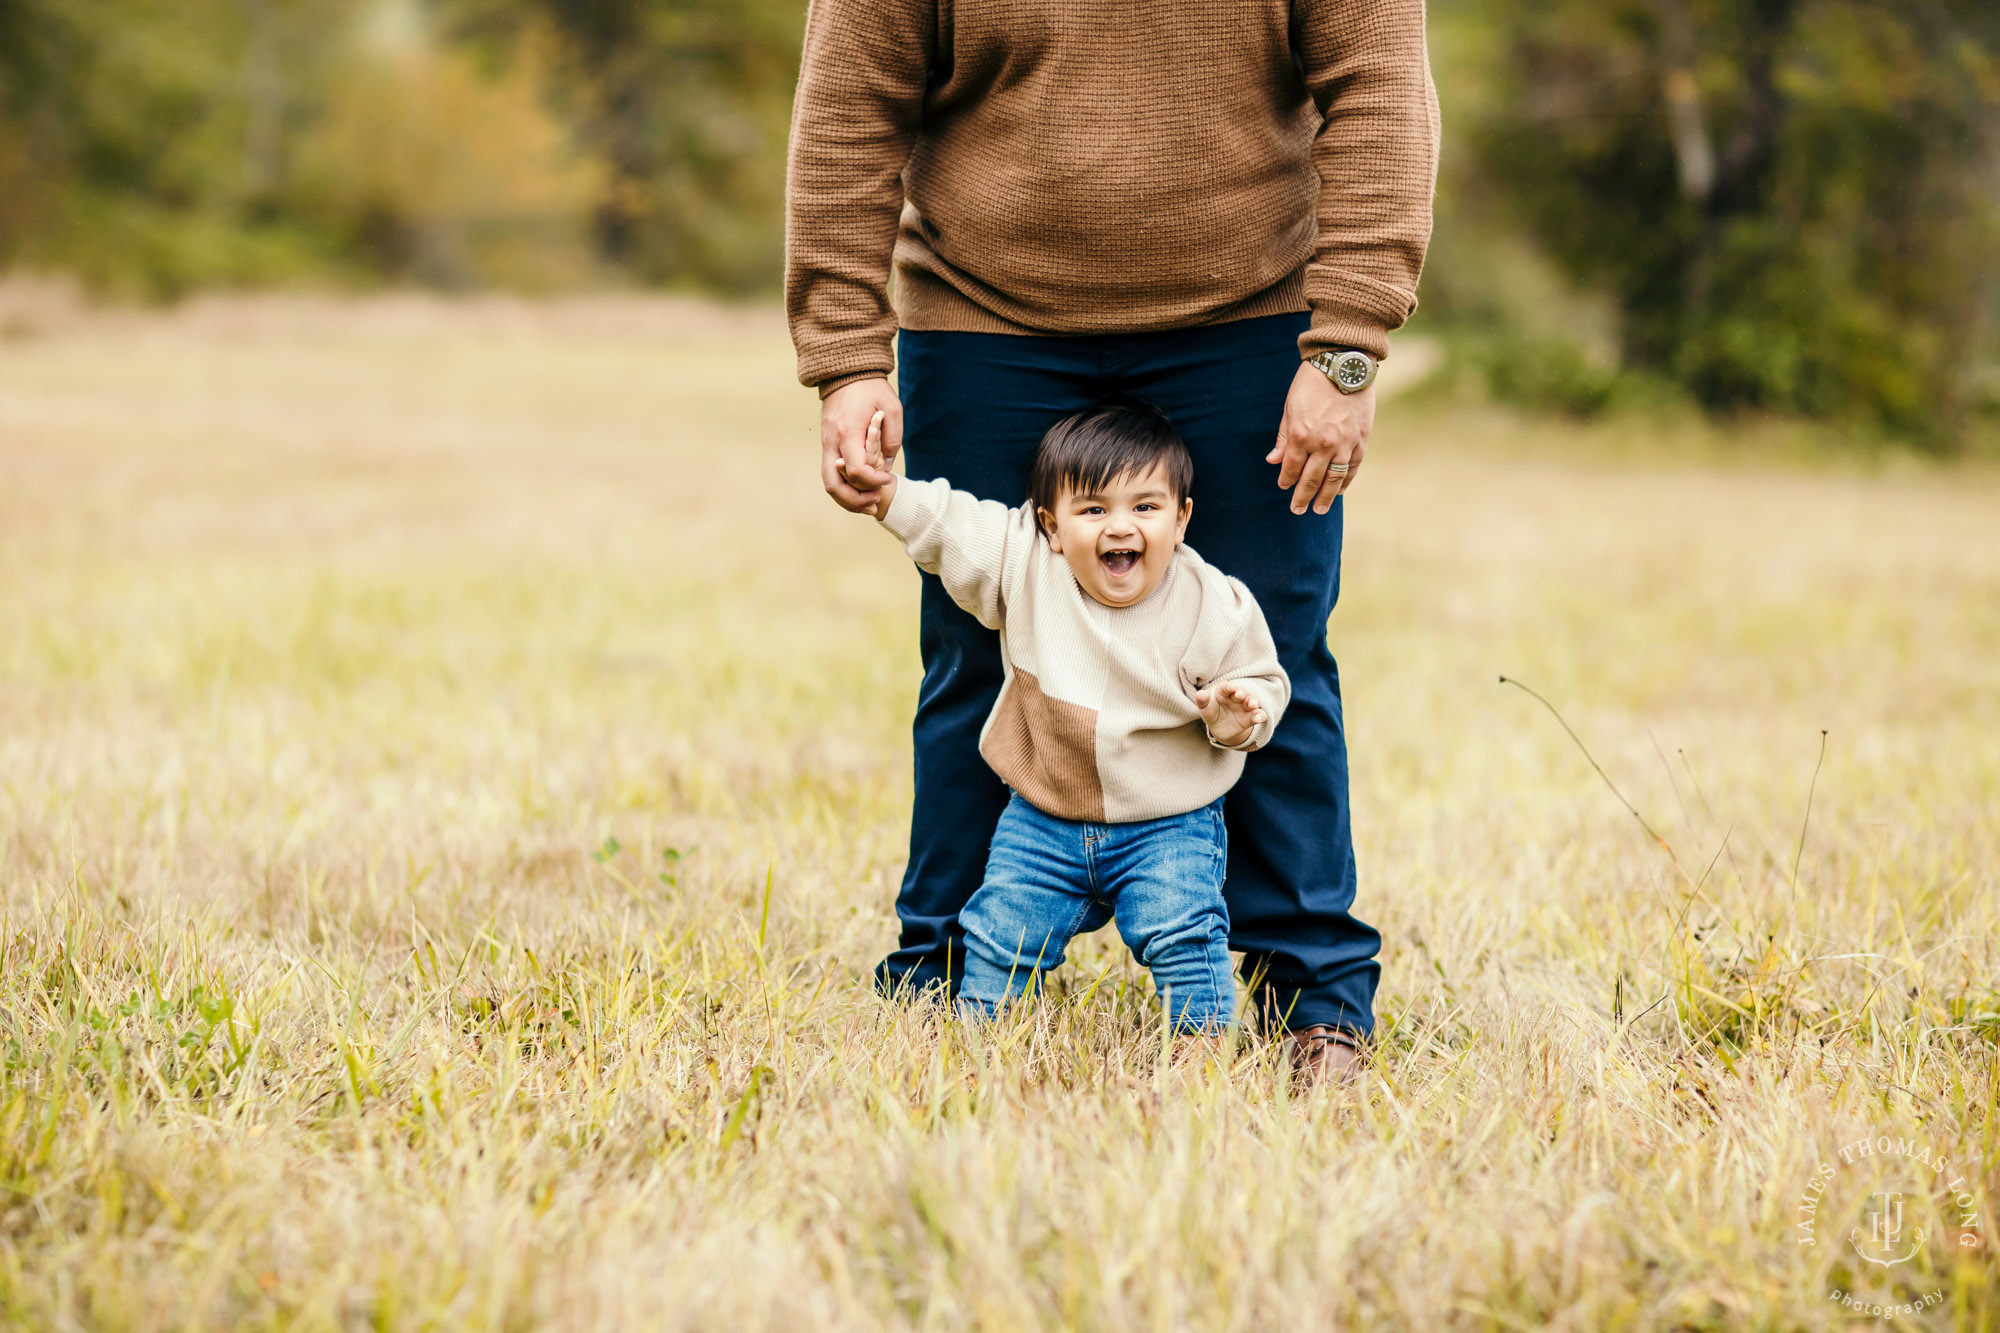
[1472,0,2000,442]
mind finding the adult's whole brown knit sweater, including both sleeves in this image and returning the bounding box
[786,0,1438,394]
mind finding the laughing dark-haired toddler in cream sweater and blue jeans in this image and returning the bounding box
[848,394,1292,1033]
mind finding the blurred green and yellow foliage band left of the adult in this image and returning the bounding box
[0,0,804,296]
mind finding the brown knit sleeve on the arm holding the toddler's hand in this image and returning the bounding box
[784,0,936,398]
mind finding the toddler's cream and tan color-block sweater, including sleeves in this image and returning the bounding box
[882,478,1292,823]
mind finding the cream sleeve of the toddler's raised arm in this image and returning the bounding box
[882,476,1042,630]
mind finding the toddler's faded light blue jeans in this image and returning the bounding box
[958,797,1236,1033]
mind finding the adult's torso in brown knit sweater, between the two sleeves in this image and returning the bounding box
[896,0,1320,332]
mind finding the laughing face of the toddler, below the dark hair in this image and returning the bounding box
[1040,456,1194,606]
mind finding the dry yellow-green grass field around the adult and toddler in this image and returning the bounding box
[0,298,2000,1333]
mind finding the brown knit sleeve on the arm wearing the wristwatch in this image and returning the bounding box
[1292,0,1440,356]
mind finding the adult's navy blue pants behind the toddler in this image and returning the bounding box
[876,314,1382,1037]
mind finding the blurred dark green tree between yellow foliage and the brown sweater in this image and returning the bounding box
[440,0,806,290]
